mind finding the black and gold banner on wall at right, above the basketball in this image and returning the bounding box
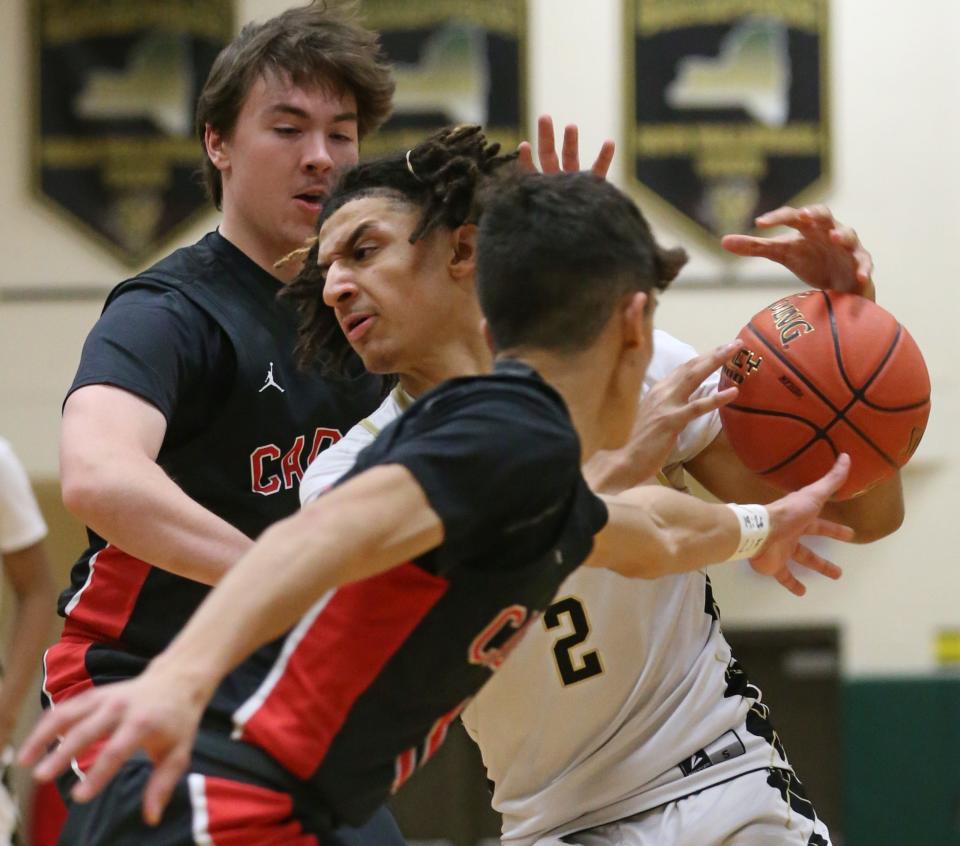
[625,0,830,249]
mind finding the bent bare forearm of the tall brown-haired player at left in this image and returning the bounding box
[63,451,253,585]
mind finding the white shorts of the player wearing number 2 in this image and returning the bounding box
[535,767,831,846]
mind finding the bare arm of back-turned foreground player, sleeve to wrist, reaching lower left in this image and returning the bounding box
[156,466,443,695]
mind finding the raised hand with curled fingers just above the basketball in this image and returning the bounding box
[720,205,876,300]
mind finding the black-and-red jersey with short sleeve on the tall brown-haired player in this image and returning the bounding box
[46,233,381,700]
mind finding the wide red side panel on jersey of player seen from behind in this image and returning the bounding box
[242,563,448,778]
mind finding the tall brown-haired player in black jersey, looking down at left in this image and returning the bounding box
[44,0,400,842]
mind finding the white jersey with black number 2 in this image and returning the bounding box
[301,330,787,846]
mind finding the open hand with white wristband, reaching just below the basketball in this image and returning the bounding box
[750,454,854,596]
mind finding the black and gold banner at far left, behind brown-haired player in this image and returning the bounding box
[32,0,233,265]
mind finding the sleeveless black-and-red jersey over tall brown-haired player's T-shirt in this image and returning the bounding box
[44,233,381,716]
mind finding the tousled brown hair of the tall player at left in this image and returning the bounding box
[196,0,394,209]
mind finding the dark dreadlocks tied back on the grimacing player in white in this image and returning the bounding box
[281,126,516,378]
